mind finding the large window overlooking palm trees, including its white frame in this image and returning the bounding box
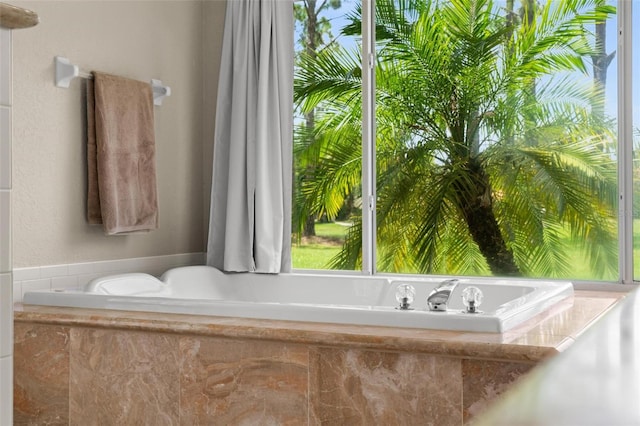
[293,0,640,282]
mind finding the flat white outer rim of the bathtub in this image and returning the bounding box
[24,265,574,333]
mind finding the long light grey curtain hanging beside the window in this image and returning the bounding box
[207,0,293,273]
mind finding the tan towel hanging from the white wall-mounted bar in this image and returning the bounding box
[87,72,158,235]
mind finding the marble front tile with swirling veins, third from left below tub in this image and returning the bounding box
[180,337,309,425]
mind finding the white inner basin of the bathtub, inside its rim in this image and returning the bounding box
[85,266,540,312]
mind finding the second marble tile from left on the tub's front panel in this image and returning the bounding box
[69,328,179,426]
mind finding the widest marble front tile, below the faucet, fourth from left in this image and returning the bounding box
[309,348,462,425]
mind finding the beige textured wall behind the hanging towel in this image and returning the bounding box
[13,0,225,268]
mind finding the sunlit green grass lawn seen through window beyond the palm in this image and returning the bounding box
[291,219,640,281]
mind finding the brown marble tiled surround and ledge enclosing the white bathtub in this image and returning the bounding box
[14,291,623,425]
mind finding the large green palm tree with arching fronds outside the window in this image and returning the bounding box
[294,0,617,276]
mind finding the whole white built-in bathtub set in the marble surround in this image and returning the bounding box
[24,266,573,332]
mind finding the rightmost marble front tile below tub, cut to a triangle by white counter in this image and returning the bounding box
[462,359,533,423]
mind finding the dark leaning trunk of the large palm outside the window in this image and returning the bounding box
[454,158,520,276]
